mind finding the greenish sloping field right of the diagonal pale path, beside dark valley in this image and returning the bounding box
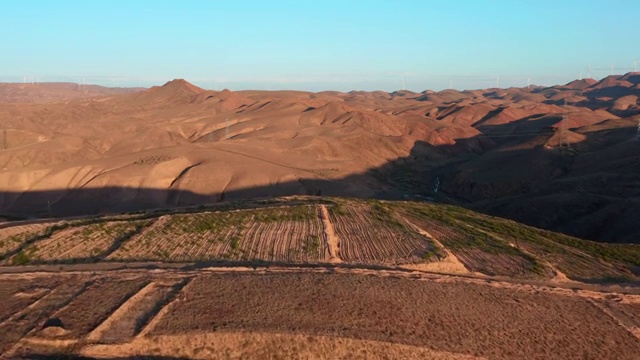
[394,204,640,281]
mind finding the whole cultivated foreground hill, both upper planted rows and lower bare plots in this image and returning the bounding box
[0,196,640,359]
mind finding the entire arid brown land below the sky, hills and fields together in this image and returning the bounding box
[0,77,640,359]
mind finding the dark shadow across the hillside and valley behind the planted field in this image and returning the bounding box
[0,116,640,242]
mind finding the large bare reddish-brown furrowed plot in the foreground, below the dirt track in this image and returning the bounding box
[152,274,640,359]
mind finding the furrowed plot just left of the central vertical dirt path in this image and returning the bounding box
[108,206,324,263]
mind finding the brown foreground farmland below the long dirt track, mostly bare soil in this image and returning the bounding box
[0,268,640,360]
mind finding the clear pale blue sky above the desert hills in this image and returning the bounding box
[0,0,640,91]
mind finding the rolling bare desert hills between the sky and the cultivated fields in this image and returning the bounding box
[0,73,640,242]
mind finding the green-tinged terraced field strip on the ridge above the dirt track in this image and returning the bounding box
[0,197,640,282]
